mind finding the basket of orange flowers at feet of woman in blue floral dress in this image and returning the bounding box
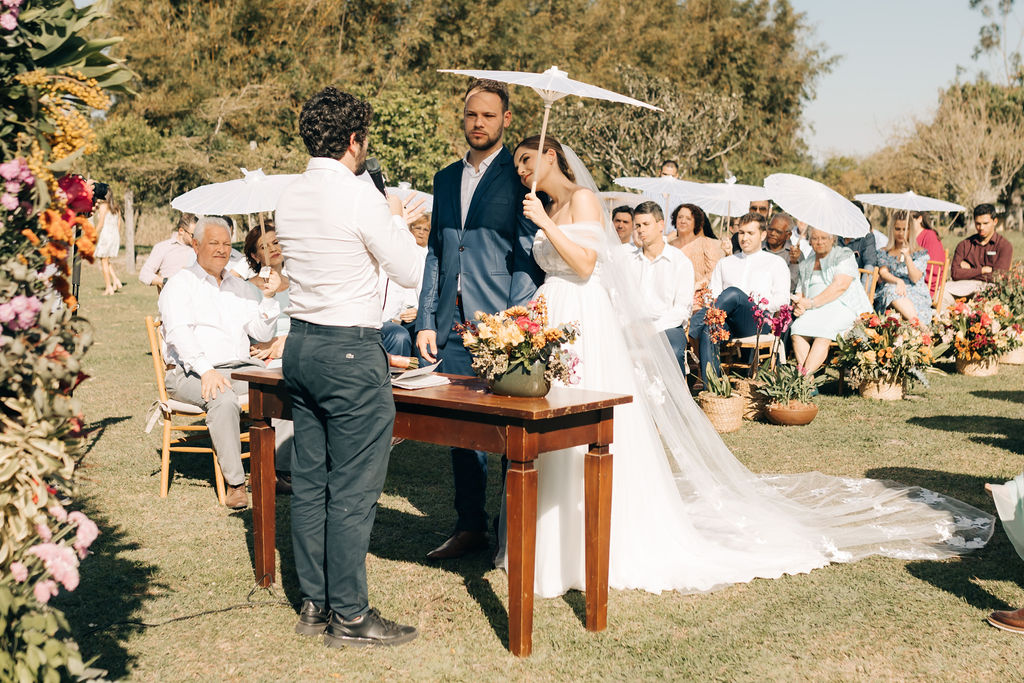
[833,313,934,400]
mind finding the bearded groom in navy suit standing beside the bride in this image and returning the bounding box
[416,80,543,559]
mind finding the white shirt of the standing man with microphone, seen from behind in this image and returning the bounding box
[274,157,423,329]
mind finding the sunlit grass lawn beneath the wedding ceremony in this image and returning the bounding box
[58,253,1024,681]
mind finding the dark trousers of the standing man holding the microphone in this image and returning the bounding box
[283,318,395,620]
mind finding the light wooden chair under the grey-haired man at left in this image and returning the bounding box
[145,315,249,505]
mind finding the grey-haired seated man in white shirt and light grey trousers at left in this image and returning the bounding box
[159,217,281,509]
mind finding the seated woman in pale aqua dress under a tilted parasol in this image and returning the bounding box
[791,228,871,374]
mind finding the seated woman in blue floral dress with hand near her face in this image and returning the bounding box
[874,217,933,326]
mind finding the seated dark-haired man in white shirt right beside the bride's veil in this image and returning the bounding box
[633,202,693,375]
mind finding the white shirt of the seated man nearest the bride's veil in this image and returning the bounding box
[633,244,693,330]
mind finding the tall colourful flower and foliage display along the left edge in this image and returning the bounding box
[0,0,132,680]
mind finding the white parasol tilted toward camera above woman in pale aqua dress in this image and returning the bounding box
[765,173,871,238]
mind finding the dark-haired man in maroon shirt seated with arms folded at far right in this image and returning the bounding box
[944,204,1014,304]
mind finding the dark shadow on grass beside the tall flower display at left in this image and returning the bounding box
[56,502,161,680]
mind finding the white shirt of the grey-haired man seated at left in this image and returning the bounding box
[159,263,281,377]
